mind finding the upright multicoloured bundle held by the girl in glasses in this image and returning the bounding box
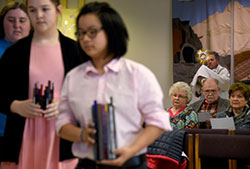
[92,98,117,160]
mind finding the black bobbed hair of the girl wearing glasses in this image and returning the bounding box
[76,2,129,61]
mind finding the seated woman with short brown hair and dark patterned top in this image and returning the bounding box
[217,82,250,129]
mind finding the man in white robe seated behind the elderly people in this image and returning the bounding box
[190,52,230,102]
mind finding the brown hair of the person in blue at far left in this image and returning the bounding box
[0,2,28,38]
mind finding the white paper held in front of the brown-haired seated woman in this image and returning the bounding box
[210,117,235,130]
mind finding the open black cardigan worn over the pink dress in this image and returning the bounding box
[0,32,80,163]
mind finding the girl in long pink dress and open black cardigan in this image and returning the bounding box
[0,0,79,169]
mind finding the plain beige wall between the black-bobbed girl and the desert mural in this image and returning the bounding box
[85,0,173,107]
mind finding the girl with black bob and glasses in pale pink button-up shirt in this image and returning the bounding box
[56,2,172,169]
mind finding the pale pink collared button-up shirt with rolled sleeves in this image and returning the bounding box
[56,58,172,159]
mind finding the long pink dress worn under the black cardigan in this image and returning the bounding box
[1,43,78,169]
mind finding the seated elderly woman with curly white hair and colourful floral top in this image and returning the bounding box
[168,82,199,129]
